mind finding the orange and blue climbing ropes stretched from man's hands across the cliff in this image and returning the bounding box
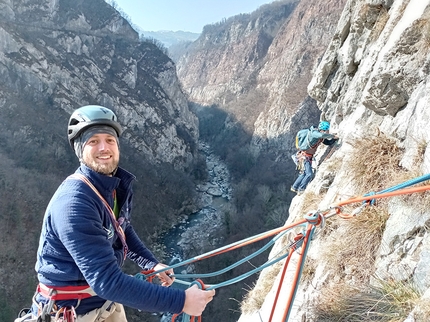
[136,174,430,322]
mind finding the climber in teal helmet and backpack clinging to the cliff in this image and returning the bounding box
[291,121,339,195]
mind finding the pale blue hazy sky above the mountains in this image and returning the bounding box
[115,0,274,33]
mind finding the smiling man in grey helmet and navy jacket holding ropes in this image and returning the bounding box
[22,105,215,322]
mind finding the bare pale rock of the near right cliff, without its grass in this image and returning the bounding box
[240,0,430,322]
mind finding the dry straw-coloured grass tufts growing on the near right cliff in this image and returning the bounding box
[242,133,430,322]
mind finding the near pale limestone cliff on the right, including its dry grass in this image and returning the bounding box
[240,0,430,322]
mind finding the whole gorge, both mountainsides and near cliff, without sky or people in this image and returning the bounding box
[0,0,430,322]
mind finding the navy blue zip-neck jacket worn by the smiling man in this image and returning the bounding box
[36,165,185,314]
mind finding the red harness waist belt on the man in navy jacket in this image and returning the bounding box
[37,283,97,300]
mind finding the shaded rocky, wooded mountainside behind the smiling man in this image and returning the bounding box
[0,0,201,322]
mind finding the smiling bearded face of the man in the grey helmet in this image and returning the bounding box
[82,133,119,175]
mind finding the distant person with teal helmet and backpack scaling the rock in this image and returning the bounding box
[291,121,339,195]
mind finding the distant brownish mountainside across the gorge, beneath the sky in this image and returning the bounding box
[177,0,346,154]
